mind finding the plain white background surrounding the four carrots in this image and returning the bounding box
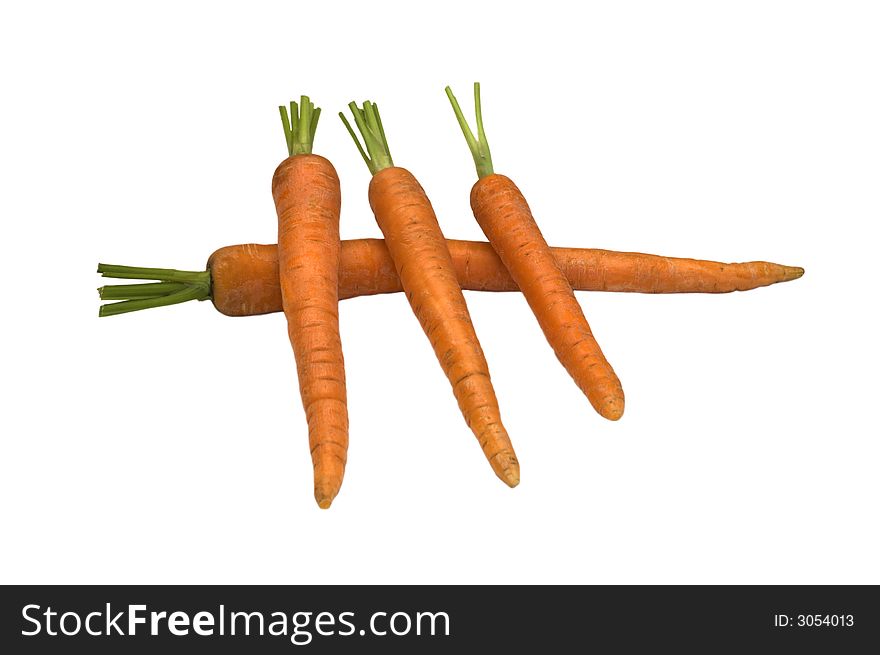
[0,1,880,583]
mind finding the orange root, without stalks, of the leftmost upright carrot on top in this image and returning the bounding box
[272,155,348,509]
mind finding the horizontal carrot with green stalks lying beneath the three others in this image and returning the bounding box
[98,239,804,316]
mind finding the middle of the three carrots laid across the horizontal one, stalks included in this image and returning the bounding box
[339,102,519,487]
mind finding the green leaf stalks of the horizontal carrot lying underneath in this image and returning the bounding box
[98,264,211,316]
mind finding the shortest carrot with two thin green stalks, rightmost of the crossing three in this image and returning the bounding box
[446,83,624,421]
